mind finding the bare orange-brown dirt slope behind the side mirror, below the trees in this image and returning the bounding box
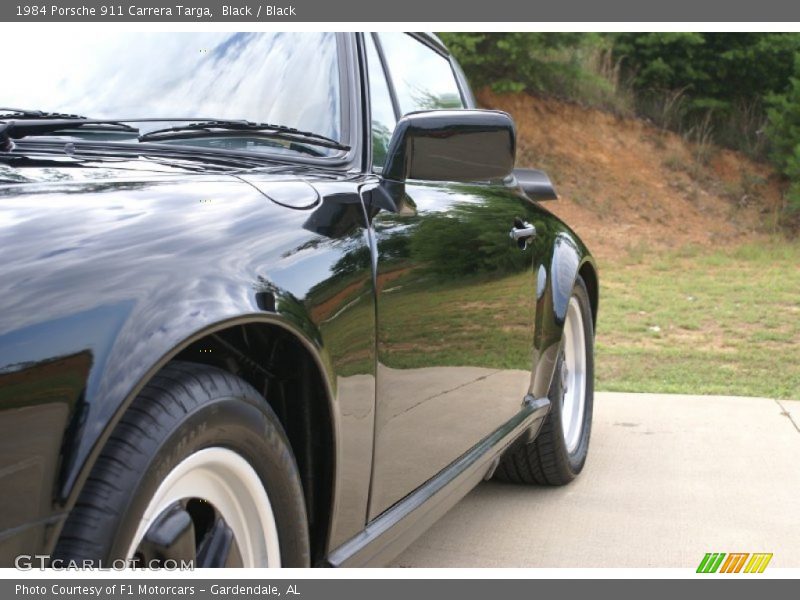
[478,91,781,261]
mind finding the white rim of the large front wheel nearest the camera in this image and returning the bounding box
[128,448,281,567]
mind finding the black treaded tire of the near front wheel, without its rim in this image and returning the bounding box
[54,361,309,567]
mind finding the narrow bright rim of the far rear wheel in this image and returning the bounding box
[561,296,586,453]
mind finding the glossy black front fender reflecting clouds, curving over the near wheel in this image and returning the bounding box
[0,165,374,556]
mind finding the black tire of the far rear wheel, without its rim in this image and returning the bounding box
[495,276,594,486]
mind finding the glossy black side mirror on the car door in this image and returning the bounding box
[382,110,516,189]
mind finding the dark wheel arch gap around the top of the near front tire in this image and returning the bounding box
[53,313,339,564]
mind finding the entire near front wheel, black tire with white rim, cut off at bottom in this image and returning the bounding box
[54,362,309,567]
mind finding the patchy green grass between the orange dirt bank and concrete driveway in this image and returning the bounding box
[596,242,800,399]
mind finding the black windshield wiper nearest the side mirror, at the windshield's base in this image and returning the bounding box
[139,120,350,151]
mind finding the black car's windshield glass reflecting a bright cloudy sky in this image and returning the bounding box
[0,32,343,155]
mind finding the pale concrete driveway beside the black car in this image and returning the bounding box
[394,393,800,568]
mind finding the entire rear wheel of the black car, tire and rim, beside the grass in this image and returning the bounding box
[495,276,594,485]
